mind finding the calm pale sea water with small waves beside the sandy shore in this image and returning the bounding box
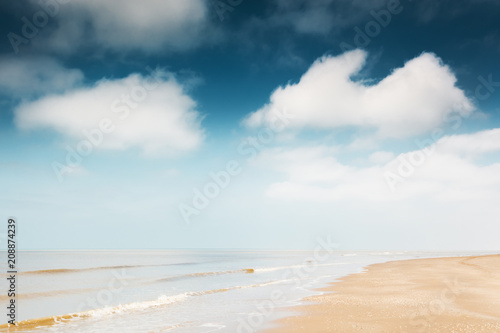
[0,250,492,333]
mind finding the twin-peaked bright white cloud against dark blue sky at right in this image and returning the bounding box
[245,50,474,138]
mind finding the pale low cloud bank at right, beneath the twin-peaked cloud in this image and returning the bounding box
[259,129,500,204]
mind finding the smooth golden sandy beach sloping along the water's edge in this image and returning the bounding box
[266,255,500,333]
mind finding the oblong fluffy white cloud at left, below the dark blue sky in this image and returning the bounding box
[15,72,204,154]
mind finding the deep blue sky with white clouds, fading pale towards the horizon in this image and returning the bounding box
[0,0,500,251]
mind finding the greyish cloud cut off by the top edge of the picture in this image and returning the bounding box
[42,0,213,52]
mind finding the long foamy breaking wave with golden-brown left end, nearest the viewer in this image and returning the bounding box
[0,280,289,331]
